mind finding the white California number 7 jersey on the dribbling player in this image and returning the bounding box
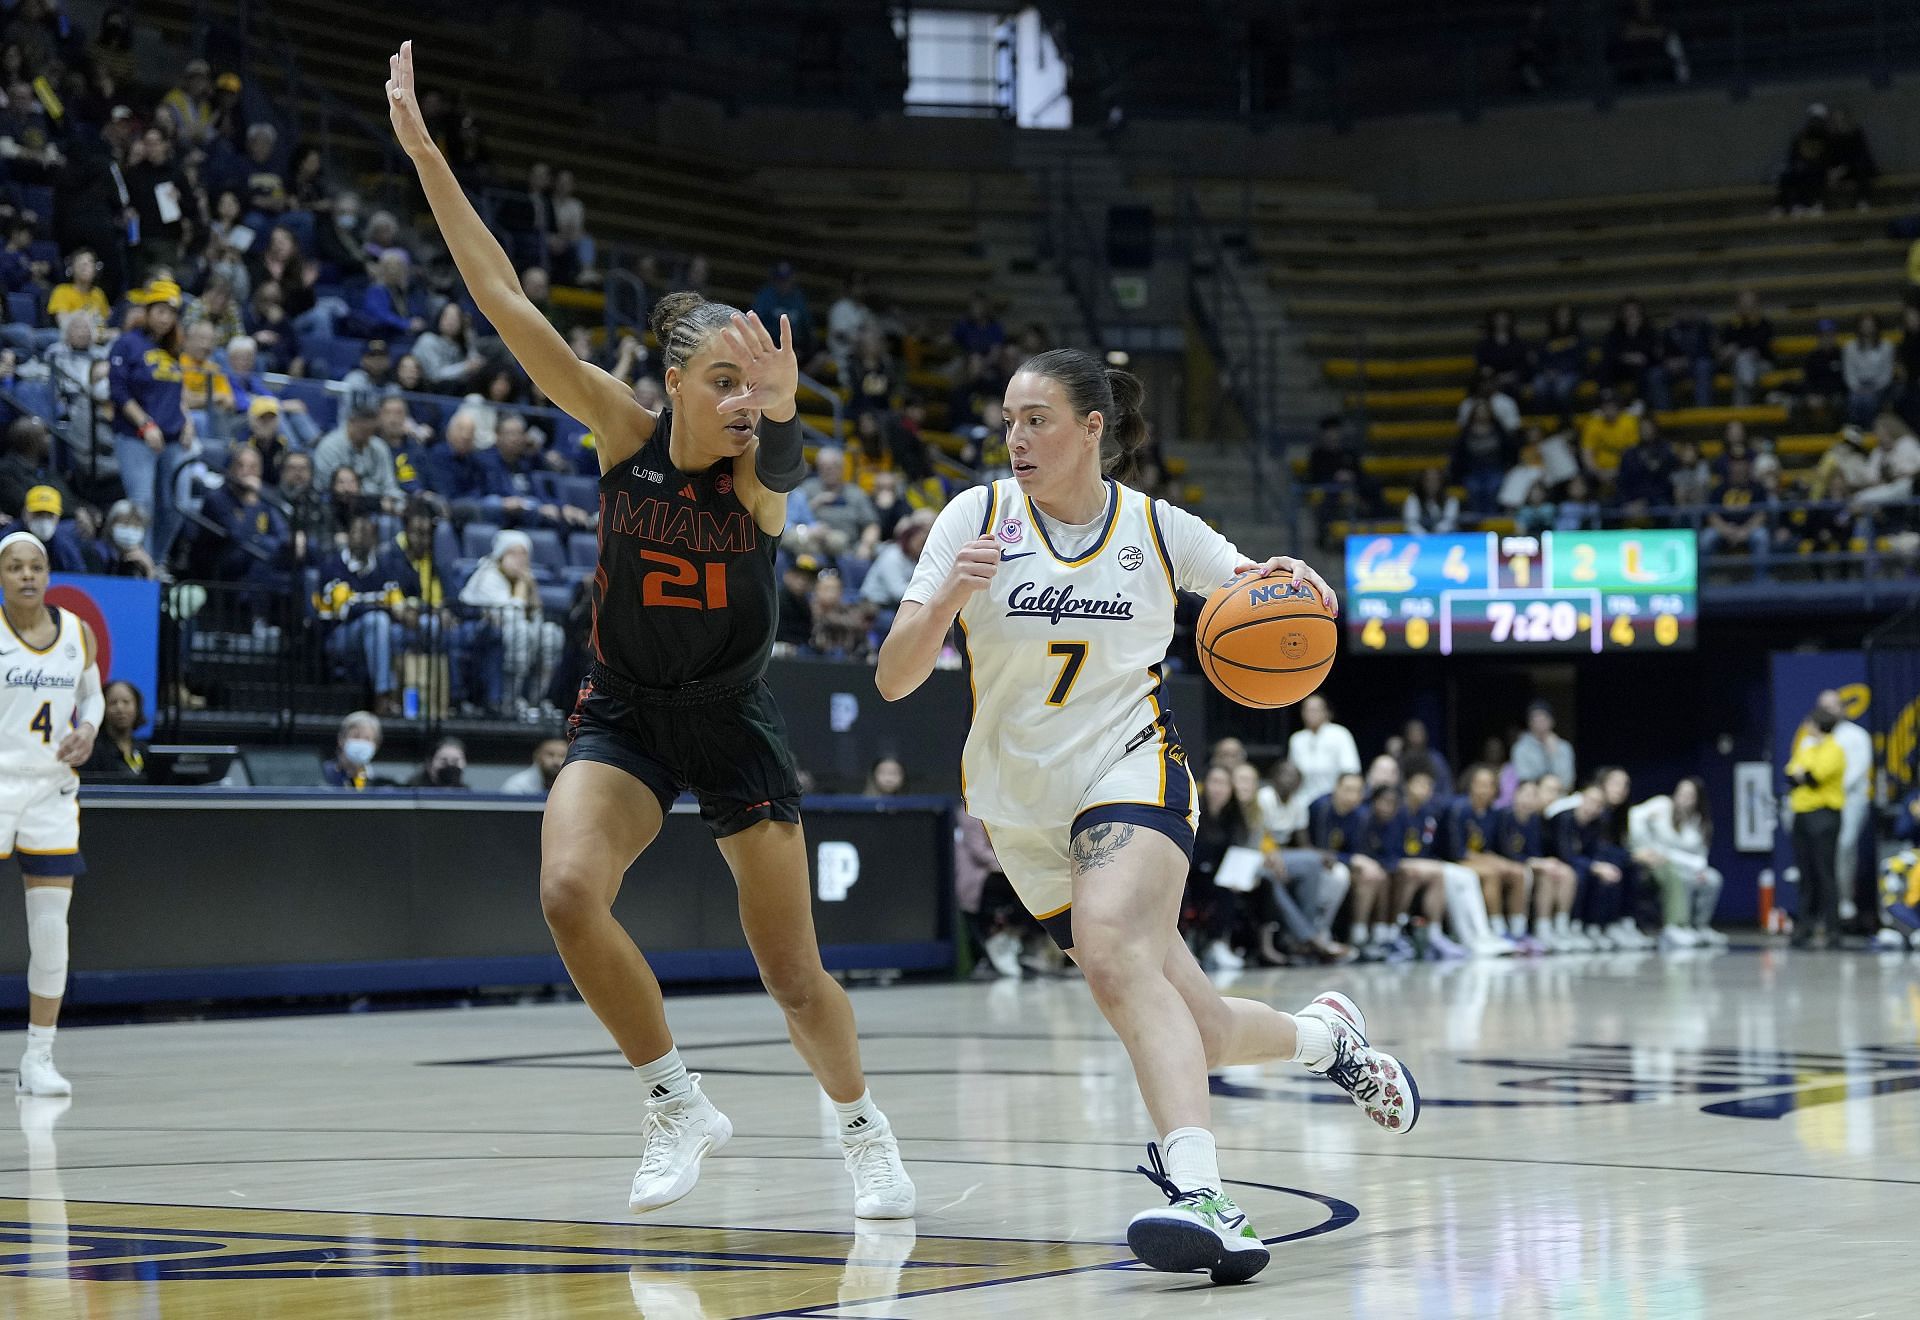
[950,478,1236,827]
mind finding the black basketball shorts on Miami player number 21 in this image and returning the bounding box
[566,664,801,838]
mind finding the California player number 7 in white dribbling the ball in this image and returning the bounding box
[876,349,1421,1282]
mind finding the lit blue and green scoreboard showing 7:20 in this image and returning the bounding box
[1342,530,1699,656]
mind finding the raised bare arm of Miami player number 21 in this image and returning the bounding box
[386,40,653,472]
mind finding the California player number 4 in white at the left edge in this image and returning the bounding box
[0,531,106,1096]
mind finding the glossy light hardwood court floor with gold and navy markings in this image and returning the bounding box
[0,952,1920,1320]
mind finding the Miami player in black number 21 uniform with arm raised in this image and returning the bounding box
[386,42,914,1218]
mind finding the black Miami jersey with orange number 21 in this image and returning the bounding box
[593,409,780,689]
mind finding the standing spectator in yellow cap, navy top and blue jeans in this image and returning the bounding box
[108,280,200,544]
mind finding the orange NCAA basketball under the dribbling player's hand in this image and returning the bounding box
[1194,574,1340,710]
